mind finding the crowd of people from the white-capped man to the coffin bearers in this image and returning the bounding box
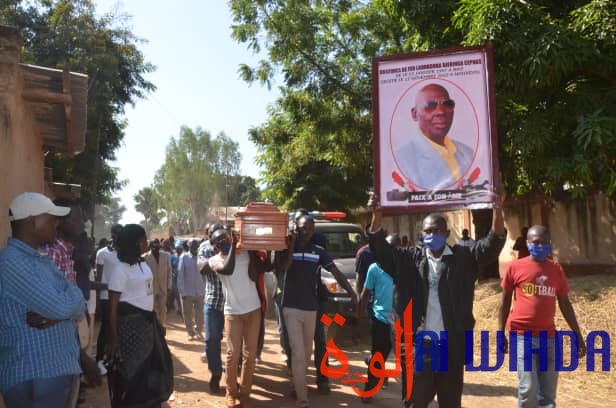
[0,193,356,408]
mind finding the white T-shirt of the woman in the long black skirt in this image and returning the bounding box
[109,262,154,312]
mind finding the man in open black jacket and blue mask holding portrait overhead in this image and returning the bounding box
[368,196,506,408]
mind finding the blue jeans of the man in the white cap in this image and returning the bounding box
[3,375,79,408]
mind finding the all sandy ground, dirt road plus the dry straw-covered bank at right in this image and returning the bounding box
[0,276,616,408]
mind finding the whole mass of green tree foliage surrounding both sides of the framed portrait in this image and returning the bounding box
[230,0,616,204]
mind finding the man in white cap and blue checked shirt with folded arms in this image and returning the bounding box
[0,193,85,408]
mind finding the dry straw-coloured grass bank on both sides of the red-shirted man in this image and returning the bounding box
[466,275,616,406]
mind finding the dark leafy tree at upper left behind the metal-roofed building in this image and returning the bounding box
[0,0,155,208]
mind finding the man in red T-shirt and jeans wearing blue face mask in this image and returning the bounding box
[498,225,586,408]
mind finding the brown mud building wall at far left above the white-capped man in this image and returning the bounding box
[0,33,45,247]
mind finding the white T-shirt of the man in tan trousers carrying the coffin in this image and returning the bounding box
[209,251,261,315]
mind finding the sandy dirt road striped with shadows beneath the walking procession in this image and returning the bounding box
[81,298,616,408]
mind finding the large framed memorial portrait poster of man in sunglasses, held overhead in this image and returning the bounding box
[372,46,498,213]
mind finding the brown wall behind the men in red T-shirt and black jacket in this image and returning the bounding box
[383,194,616,274]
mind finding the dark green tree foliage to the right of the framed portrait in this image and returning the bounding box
[453,0,616,196]
